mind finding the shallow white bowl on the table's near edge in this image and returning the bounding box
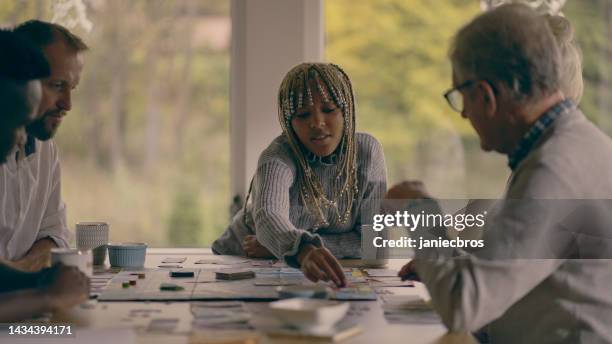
[269,298,350,331]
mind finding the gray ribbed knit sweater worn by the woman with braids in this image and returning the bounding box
[212,133,387,265]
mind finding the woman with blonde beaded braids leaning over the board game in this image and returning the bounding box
[212,63,386,286]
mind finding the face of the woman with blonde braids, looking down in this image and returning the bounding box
[291,86,344,157]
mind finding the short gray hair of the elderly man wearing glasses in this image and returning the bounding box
[449,4,560,101]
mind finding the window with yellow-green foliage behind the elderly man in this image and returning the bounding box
[325,0,612,198]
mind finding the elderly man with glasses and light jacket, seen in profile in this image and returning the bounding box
[387,5,612,343]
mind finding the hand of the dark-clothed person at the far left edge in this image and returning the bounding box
[45,265,89,311]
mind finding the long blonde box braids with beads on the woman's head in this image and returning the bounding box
[278,63,358,229]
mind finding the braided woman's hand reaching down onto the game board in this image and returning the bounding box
[298,245,346,287]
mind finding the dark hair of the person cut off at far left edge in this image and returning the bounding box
[0,29,51,81]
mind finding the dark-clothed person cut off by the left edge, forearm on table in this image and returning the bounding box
[0,30,89,322]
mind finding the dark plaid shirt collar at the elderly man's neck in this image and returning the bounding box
[508,99,576,171]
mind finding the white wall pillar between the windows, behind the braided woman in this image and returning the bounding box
[230,0,324,203]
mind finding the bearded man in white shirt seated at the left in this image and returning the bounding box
[0,20,87,271]
